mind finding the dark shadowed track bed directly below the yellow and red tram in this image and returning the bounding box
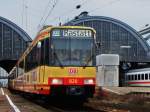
[24,95,103,112]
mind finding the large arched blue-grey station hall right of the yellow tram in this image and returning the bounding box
[65,12,150,68]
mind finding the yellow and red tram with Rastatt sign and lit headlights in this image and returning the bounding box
[8,26,96,99]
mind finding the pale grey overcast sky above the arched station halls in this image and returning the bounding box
[0,0,150,39]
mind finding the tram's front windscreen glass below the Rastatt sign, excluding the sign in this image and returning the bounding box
[52,37,94,66]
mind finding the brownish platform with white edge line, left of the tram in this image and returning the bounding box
[0,88,51,112]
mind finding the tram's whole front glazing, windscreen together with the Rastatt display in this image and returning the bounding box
[51,29,94,66]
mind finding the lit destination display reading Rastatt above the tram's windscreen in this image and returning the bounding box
[52,29,92,37]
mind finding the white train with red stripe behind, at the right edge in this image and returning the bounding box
[125,68,150,87]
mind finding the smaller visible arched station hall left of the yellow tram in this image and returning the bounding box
[0,17,32,72]
